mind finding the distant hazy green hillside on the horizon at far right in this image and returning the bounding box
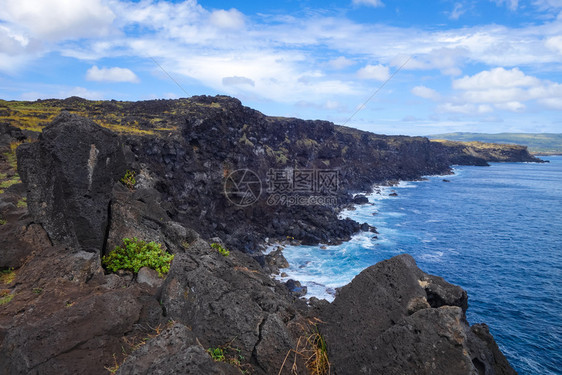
[428,133,562,154]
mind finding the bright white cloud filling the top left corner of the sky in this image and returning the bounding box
[0,0,115,40]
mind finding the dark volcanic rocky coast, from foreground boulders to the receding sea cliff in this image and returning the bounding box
[0,97,514,374]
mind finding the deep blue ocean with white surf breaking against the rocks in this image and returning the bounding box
[278,156,562,374]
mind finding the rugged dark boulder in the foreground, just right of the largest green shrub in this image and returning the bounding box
[162,240,297,374]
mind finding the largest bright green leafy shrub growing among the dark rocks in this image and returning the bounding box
[102,237,174,277]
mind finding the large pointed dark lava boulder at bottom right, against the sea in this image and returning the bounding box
[321,255,515,375]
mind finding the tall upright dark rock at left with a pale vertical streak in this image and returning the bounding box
[17,112,126,252]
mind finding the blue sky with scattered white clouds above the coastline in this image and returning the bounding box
[0,0,562,135]
